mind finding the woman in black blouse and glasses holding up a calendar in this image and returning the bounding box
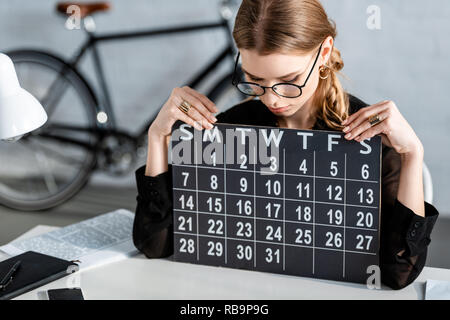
[133,0,438,289]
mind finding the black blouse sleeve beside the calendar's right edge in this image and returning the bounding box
[380,146,439,289]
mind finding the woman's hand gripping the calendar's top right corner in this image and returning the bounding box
[342,100,423,156]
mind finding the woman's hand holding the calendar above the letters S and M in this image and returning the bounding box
[148,86,219,137]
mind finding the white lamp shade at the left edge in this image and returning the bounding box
[0,53,47,140]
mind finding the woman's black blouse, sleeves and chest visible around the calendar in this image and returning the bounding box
[133,94,439,289]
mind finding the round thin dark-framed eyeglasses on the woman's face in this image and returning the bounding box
[232,42,323,98]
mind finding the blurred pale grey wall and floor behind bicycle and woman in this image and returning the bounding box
[0,0,450,268]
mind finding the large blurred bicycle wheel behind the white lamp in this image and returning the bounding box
[0,50,96,211]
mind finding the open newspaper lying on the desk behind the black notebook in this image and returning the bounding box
[0,209,138,269]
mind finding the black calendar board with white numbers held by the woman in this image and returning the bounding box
[169,121,381,283]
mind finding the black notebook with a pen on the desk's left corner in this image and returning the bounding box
[0,251,78,300]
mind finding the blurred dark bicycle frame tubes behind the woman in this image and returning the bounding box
[64,19,237,137]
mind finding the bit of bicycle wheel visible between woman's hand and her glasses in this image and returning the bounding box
[207,74,247,111]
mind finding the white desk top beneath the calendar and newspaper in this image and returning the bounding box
[2,226,450,300]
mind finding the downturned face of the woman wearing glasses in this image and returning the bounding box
[240,37,333,117]
